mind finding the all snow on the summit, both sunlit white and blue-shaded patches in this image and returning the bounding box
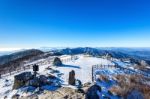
[0,54,149,99]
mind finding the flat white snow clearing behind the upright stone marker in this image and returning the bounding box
[57,55,112,83]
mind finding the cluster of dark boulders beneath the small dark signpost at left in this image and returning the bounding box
[13,72,60,89]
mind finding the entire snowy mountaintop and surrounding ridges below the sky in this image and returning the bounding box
[0,48,150,99]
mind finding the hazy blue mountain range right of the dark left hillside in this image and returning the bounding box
[55,47,150,64]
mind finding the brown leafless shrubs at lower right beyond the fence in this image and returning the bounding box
[113,75,150,99]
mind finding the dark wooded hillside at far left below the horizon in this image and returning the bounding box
[0,49,44,74]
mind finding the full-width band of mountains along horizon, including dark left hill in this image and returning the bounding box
[0,47,150,72]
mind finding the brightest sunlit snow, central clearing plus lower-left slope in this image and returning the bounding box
[0,55,126,99]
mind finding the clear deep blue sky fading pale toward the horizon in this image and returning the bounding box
[0,0,150,49]
